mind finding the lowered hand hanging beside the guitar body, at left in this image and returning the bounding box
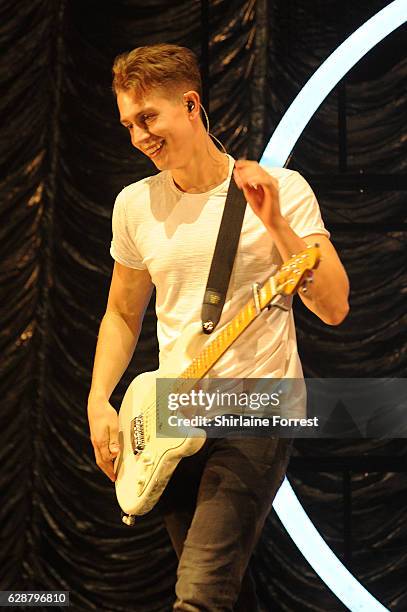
[88,398,120,482]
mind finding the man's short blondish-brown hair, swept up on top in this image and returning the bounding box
[113,44,202,97]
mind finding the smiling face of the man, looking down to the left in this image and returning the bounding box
[117,89,199,170]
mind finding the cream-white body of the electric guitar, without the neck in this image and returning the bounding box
[114,324,209,515]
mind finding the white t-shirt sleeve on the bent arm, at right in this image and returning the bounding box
[279,171,330,238]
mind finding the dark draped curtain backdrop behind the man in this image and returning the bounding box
[0,0,407,612]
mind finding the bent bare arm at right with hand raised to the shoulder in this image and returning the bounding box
[234,160,349,325]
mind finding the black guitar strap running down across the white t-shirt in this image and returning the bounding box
[201,173,246,334]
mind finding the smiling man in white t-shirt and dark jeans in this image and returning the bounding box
[88,45,349,612]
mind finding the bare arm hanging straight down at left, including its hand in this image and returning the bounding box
[88,262,153,481]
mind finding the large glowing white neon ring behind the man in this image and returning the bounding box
[268,0,407,612]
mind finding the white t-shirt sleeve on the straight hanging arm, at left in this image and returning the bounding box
[110,190,146,270]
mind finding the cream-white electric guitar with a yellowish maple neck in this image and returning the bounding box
[114,245,320,524]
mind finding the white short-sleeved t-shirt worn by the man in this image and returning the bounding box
[110,156,329,378]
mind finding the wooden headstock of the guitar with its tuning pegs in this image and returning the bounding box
[274,244,321,295]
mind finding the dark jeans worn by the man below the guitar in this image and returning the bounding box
[158,437,292,612]
